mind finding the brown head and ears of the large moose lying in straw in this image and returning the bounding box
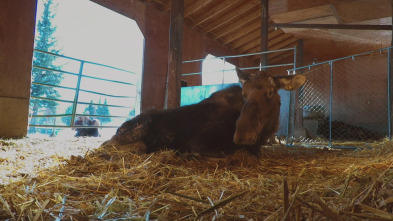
[233,70,306,145]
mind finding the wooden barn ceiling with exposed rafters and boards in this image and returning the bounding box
[144,0,392,63]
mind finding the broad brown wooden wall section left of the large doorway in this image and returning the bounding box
[0,0,37,138]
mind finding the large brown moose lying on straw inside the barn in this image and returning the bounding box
[101,68,306,157]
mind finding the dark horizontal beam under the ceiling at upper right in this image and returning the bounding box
[269,23,392,30]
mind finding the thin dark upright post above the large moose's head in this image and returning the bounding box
[261,0,269,70]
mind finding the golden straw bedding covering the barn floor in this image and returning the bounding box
[0,138,393,220]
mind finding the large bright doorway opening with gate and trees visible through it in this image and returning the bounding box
[28,0,144,137]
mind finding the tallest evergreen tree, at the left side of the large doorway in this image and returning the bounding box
[29,0,63,133]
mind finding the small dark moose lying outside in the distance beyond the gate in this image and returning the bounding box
[72,116,101,137]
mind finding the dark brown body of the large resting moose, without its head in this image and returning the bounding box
[104,86,243,156]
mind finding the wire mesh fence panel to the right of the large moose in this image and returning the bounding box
[288,49,389,148]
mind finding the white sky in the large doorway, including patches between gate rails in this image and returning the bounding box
[33,0,144,136]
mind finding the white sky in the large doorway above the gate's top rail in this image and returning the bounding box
[37,0,144,72]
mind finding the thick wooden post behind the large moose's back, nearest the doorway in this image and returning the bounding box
[165,0,184,109]
